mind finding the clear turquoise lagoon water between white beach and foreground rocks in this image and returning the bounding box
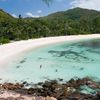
[0,39,100,83]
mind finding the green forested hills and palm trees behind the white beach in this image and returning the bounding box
[0,8,100,43]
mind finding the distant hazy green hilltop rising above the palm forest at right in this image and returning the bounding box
[45,8,100,20]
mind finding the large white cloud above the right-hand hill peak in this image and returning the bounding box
[70,0,100,11]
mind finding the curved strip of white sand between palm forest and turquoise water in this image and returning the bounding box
[0,34,100,67]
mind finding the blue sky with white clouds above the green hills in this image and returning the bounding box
[0,0,100,17]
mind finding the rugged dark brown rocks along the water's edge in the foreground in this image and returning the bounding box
[0,77,100,100]
